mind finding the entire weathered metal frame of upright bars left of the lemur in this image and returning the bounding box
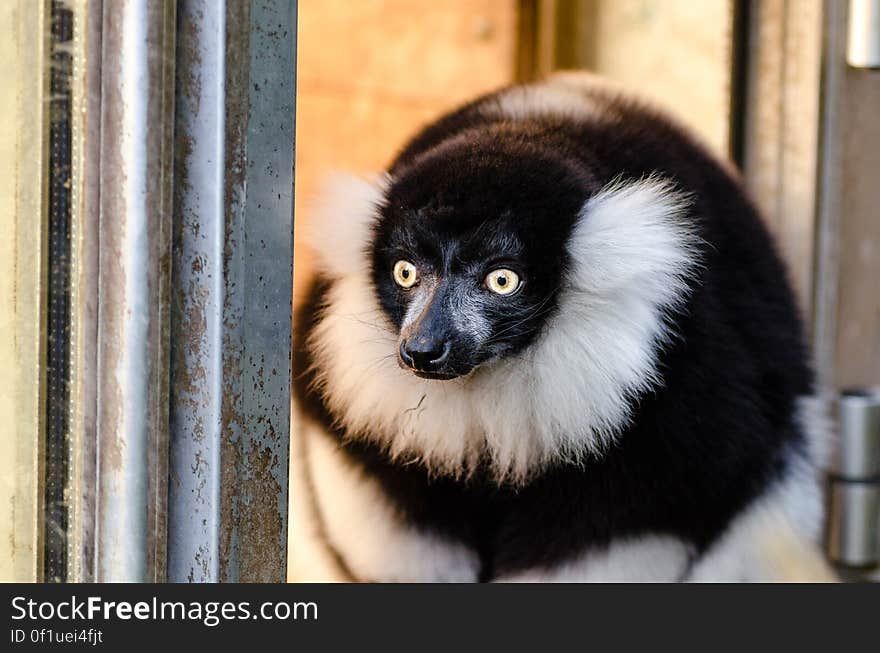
[0,0,296,582]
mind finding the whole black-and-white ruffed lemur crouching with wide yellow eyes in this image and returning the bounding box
[293,77,824,581]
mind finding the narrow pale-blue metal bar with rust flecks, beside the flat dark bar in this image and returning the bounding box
[168,0,226,582]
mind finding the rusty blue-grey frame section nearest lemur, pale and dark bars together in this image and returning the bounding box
[168,0,296,582]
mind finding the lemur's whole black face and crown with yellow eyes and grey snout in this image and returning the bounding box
[372,140,587,379]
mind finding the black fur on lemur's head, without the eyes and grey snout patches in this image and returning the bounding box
[372,129,598,375]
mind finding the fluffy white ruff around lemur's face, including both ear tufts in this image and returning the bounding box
[309,172,697,482]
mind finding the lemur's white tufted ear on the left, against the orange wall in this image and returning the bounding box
[304,173,389,277]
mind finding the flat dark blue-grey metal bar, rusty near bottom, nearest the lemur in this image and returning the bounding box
[221,0,296,582]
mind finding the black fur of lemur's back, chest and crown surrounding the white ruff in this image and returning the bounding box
[294,83,812,580]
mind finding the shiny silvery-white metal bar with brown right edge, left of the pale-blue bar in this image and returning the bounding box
[96,0,174,581]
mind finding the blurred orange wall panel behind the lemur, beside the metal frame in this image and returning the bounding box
[295,0,519,301]
